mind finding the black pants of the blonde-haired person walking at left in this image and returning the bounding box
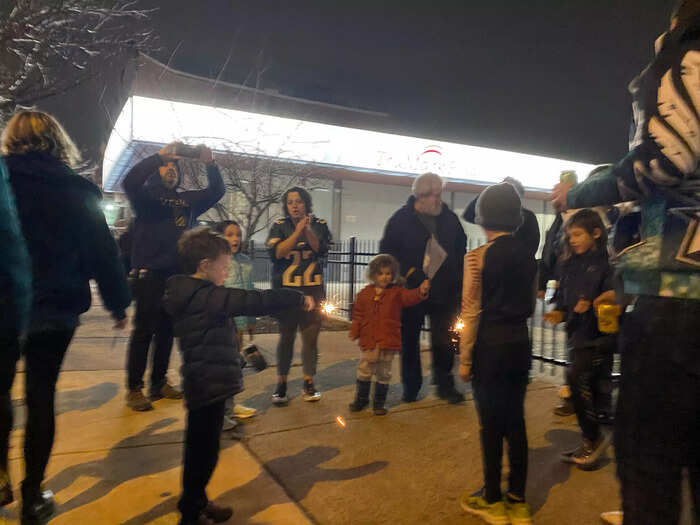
[0,328,75,503]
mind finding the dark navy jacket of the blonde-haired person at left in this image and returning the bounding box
[4,152,131,329]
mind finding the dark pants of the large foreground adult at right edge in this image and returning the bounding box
[615,296,700,525]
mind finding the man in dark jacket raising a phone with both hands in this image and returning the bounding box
[122,142,225,411]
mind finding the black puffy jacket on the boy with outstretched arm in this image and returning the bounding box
[163,275,304,410]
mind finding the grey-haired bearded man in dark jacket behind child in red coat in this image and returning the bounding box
[379,173,467,403]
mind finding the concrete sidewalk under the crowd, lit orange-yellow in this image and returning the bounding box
[0,309,619,525]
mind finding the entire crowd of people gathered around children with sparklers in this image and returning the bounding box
[0,0,700,525]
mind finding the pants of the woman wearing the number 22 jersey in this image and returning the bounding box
[277,310,321,377]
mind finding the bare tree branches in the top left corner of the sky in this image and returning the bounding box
[0,0,156,119]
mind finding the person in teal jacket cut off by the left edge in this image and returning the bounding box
[0,159,32,507]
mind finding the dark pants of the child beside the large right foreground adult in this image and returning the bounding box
[566,341,614,441]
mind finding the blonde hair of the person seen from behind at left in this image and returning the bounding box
[0,111,80,167]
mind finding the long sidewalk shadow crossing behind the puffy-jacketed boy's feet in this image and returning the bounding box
[122,447,388,525]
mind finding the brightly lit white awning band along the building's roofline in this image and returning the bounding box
[103,96,594,191]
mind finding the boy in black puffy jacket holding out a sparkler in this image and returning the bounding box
[163,228,314,525]
